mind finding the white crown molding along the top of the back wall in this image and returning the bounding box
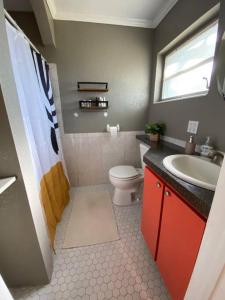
[55,12,153,28]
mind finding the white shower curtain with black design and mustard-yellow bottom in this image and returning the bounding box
[6,20,69,245]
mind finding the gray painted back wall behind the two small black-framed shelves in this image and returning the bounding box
[41,21,152,133]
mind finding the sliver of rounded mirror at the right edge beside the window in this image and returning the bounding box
[217,32,225,100]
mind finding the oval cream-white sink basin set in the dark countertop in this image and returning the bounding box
[163,154,220,191]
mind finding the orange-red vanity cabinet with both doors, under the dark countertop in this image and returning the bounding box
[141,168,205,300]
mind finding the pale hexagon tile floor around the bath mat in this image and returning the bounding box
[12,185,170,300]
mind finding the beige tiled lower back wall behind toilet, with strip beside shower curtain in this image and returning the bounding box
[50,64,142,186]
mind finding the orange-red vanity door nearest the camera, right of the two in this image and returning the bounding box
[157,187,205,300]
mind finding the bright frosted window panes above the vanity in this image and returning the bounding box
[162,21,218,101]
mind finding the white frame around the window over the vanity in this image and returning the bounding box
[159,19,219,103]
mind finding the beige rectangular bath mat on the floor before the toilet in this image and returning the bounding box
[63,191,119,248]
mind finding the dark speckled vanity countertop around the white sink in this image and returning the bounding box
[136,135,214,219]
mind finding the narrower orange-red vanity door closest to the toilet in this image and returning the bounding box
[141,168,163,258]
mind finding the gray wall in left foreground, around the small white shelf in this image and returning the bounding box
[0,88,48,286]
